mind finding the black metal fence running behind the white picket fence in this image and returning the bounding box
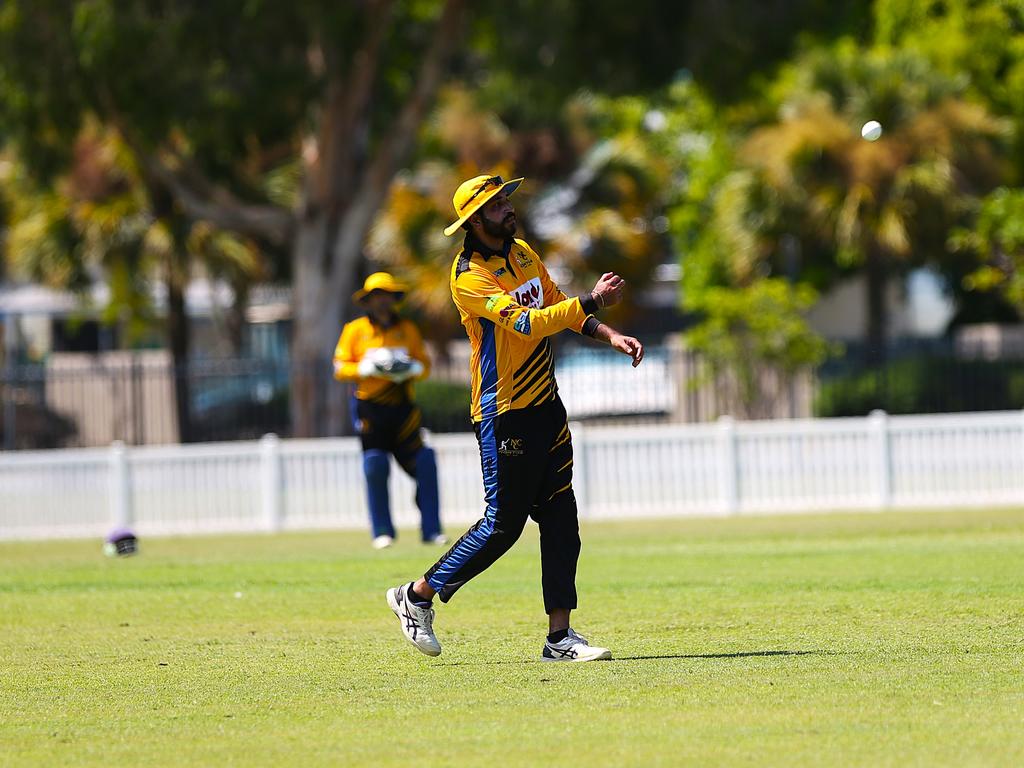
[8,339,1024,450]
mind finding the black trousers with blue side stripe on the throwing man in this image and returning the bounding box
[424,395,580,613]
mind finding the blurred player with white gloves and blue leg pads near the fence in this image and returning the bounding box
[334,272,447,549]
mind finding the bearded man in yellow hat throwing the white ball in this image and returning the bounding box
[387,176,643,662]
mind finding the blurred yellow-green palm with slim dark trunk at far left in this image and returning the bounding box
[0,123,262,441]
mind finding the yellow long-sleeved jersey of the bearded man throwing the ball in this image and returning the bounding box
[451,233,597,421]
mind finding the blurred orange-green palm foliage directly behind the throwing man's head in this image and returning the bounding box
[367,90,672,349]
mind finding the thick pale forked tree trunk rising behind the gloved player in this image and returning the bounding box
[291,0,466,437]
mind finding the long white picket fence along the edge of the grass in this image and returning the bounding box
[0,411,1024,539]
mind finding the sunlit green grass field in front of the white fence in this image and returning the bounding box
[0,510,1024,768]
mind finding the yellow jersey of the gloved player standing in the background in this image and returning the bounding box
[334,317,430,406]
